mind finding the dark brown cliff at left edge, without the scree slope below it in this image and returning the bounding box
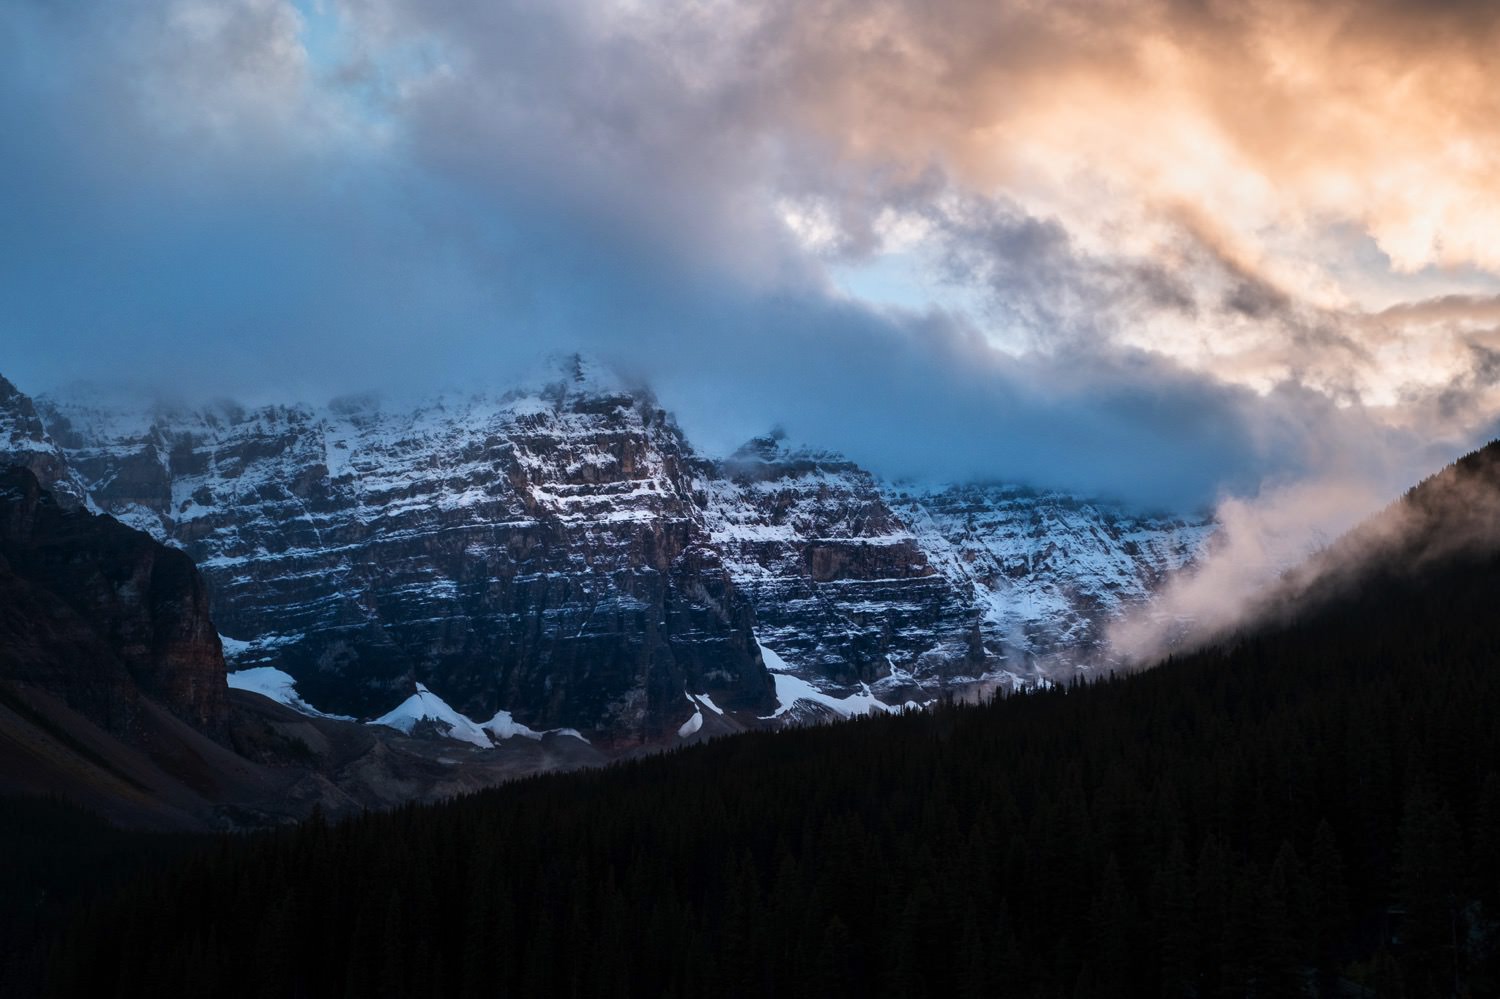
[0,465,228,734]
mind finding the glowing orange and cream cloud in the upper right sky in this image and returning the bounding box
[660,0,1500,405]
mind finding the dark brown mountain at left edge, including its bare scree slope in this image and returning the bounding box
[0,465,266,828]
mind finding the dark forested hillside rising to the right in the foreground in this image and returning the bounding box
[23,450,1500,998]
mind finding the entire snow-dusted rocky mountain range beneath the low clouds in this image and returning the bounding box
[0,357,1211,744]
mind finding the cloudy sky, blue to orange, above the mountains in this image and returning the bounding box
[0,0,1500,513]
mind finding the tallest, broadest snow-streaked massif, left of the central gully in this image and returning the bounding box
[38,363,776,741]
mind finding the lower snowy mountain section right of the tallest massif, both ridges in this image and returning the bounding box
[707,435,1214,698]
